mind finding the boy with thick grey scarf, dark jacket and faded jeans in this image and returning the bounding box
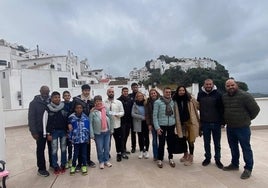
[44,91,68,175]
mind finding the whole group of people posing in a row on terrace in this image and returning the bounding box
[28,79,260,179]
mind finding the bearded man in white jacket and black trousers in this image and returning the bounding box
[104,88,128,162]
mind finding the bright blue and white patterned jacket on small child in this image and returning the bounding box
[68,113,90,144]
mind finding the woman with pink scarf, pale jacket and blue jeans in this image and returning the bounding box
[90,95,113,169]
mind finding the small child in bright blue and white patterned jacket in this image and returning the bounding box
[68,103,90,175]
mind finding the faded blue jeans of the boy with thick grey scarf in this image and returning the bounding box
[51,130,66,168]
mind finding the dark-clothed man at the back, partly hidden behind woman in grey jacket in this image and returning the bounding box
[128,82,139,153]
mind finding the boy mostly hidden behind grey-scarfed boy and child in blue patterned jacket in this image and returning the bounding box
[62,91,73,168]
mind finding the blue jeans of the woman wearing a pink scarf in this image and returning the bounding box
[95,131,111,163]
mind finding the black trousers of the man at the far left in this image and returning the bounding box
[36,132,52,170]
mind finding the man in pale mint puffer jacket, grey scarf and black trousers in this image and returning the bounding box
[153,87,176,168]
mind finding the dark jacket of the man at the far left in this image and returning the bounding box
[28,95,49,135]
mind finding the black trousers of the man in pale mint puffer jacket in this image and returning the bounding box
[158,125,175,161]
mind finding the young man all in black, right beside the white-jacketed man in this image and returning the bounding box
[118,87,132,154]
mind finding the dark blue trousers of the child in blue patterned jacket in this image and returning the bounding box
[72,143,87,167]
